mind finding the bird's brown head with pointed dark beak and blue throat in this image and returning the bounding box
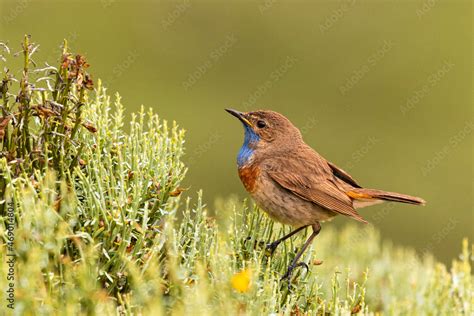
[226,109,301,165]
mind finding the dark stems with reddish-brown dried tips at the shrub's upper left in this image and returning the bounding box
[0,36,96,214]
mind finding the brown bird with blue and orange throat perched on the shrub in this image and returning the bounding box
[225,108,426,288]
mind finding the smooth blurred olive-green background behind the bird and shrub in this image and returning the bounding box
[0,0,474,261]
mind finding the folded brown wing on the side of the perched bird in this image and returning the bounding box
[264,148,365,222]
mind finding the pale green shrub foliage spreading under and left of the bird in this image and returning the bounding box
[0,38,473,315]
